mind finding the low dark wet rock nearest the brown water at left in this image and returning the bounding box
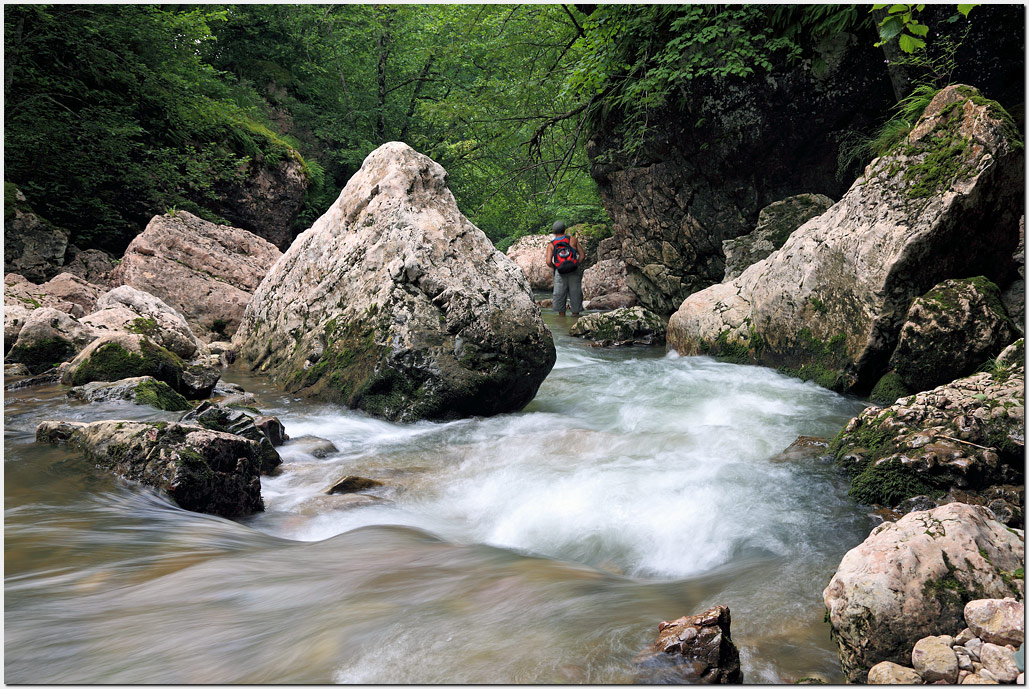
[36,421,264,517]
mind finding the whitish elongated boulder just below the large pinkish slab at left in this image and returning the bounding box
[82,285,204,359]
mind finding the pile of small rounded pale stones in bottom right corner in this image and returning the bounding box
[868,597,1025,684]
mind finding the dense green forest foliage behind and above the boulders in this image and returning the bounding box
[4,5,1021,255]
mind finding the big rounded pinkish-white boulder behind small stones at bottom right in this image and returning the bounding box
[822,503,1025,682]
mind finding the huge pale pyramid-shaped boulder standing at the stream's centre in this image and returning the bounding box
[233,142,556,421]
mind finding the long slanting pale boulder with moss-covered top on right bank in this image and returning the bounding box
[668,86,1024,392]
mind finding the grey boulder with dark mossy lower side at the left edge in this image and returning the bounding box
[4,306,98,373]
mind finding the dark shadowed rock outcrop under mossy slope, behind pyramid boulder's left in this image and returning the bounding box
[202,152,310,251]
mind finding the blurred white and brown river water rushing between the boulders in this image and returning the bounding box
[4,314,872,684]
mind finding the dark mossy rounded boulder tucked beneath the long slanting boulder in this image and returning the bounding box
[889,277,1017,391]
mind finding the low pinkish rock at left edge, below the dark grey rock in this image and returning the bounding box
[3,273,103,352]
